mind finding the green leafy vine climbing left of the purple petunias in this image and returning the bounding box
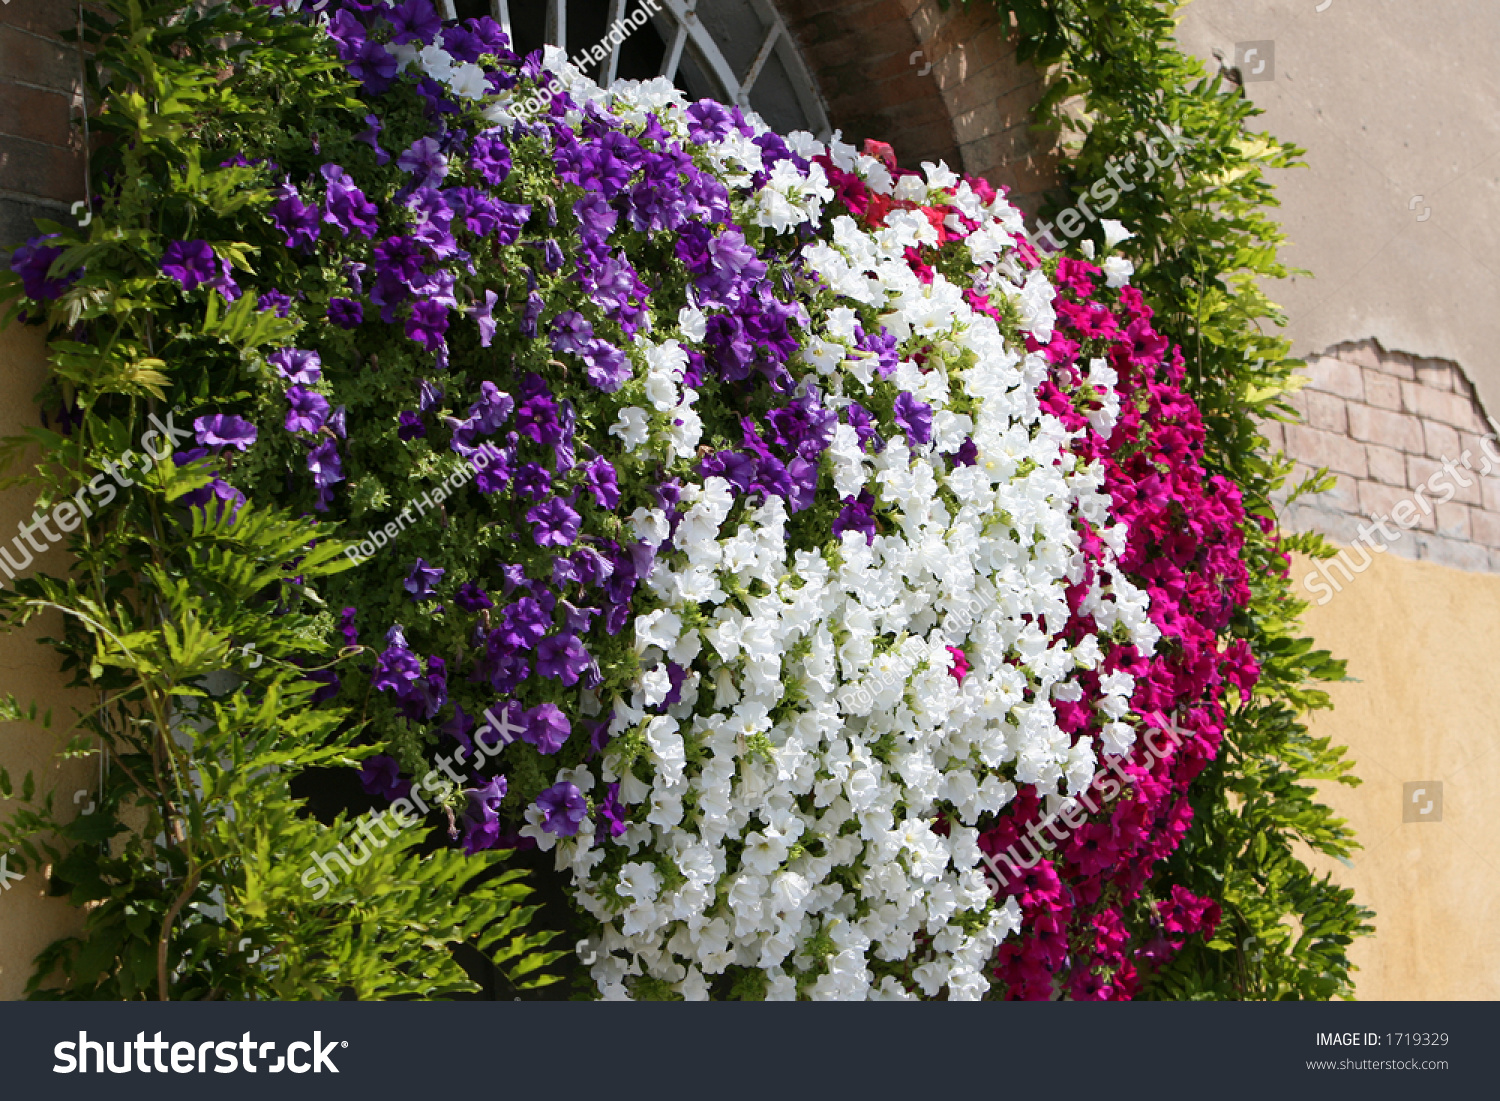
[0,0,561,999]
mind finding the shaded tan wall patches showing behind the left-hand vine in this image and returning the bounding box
[0,326,88,1001]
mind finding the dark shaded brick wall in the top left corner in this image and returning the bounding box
[0,0,84,254]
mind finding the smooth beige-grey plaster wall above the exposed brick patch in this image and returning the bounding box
[1178,0,1500,423]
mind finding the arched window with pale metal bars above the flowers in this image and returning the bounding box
[440,0,830,138]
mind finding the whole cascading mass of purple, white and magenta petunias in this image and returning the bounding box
[38,0,1253,999]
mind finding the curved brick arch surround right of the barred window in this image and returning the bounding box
[780,0,1058,212]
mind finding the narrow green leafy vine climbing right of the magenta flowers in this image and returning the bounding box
[987,0,1373,999]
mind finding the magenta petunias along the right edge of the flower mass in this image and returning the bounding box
[981,260,1257,999]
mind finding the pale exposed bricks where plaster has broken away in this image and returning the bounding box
[1266,341,1500,572]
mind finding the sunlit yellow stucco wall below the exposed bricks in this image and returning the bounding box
[1293,552,1500,1001]
